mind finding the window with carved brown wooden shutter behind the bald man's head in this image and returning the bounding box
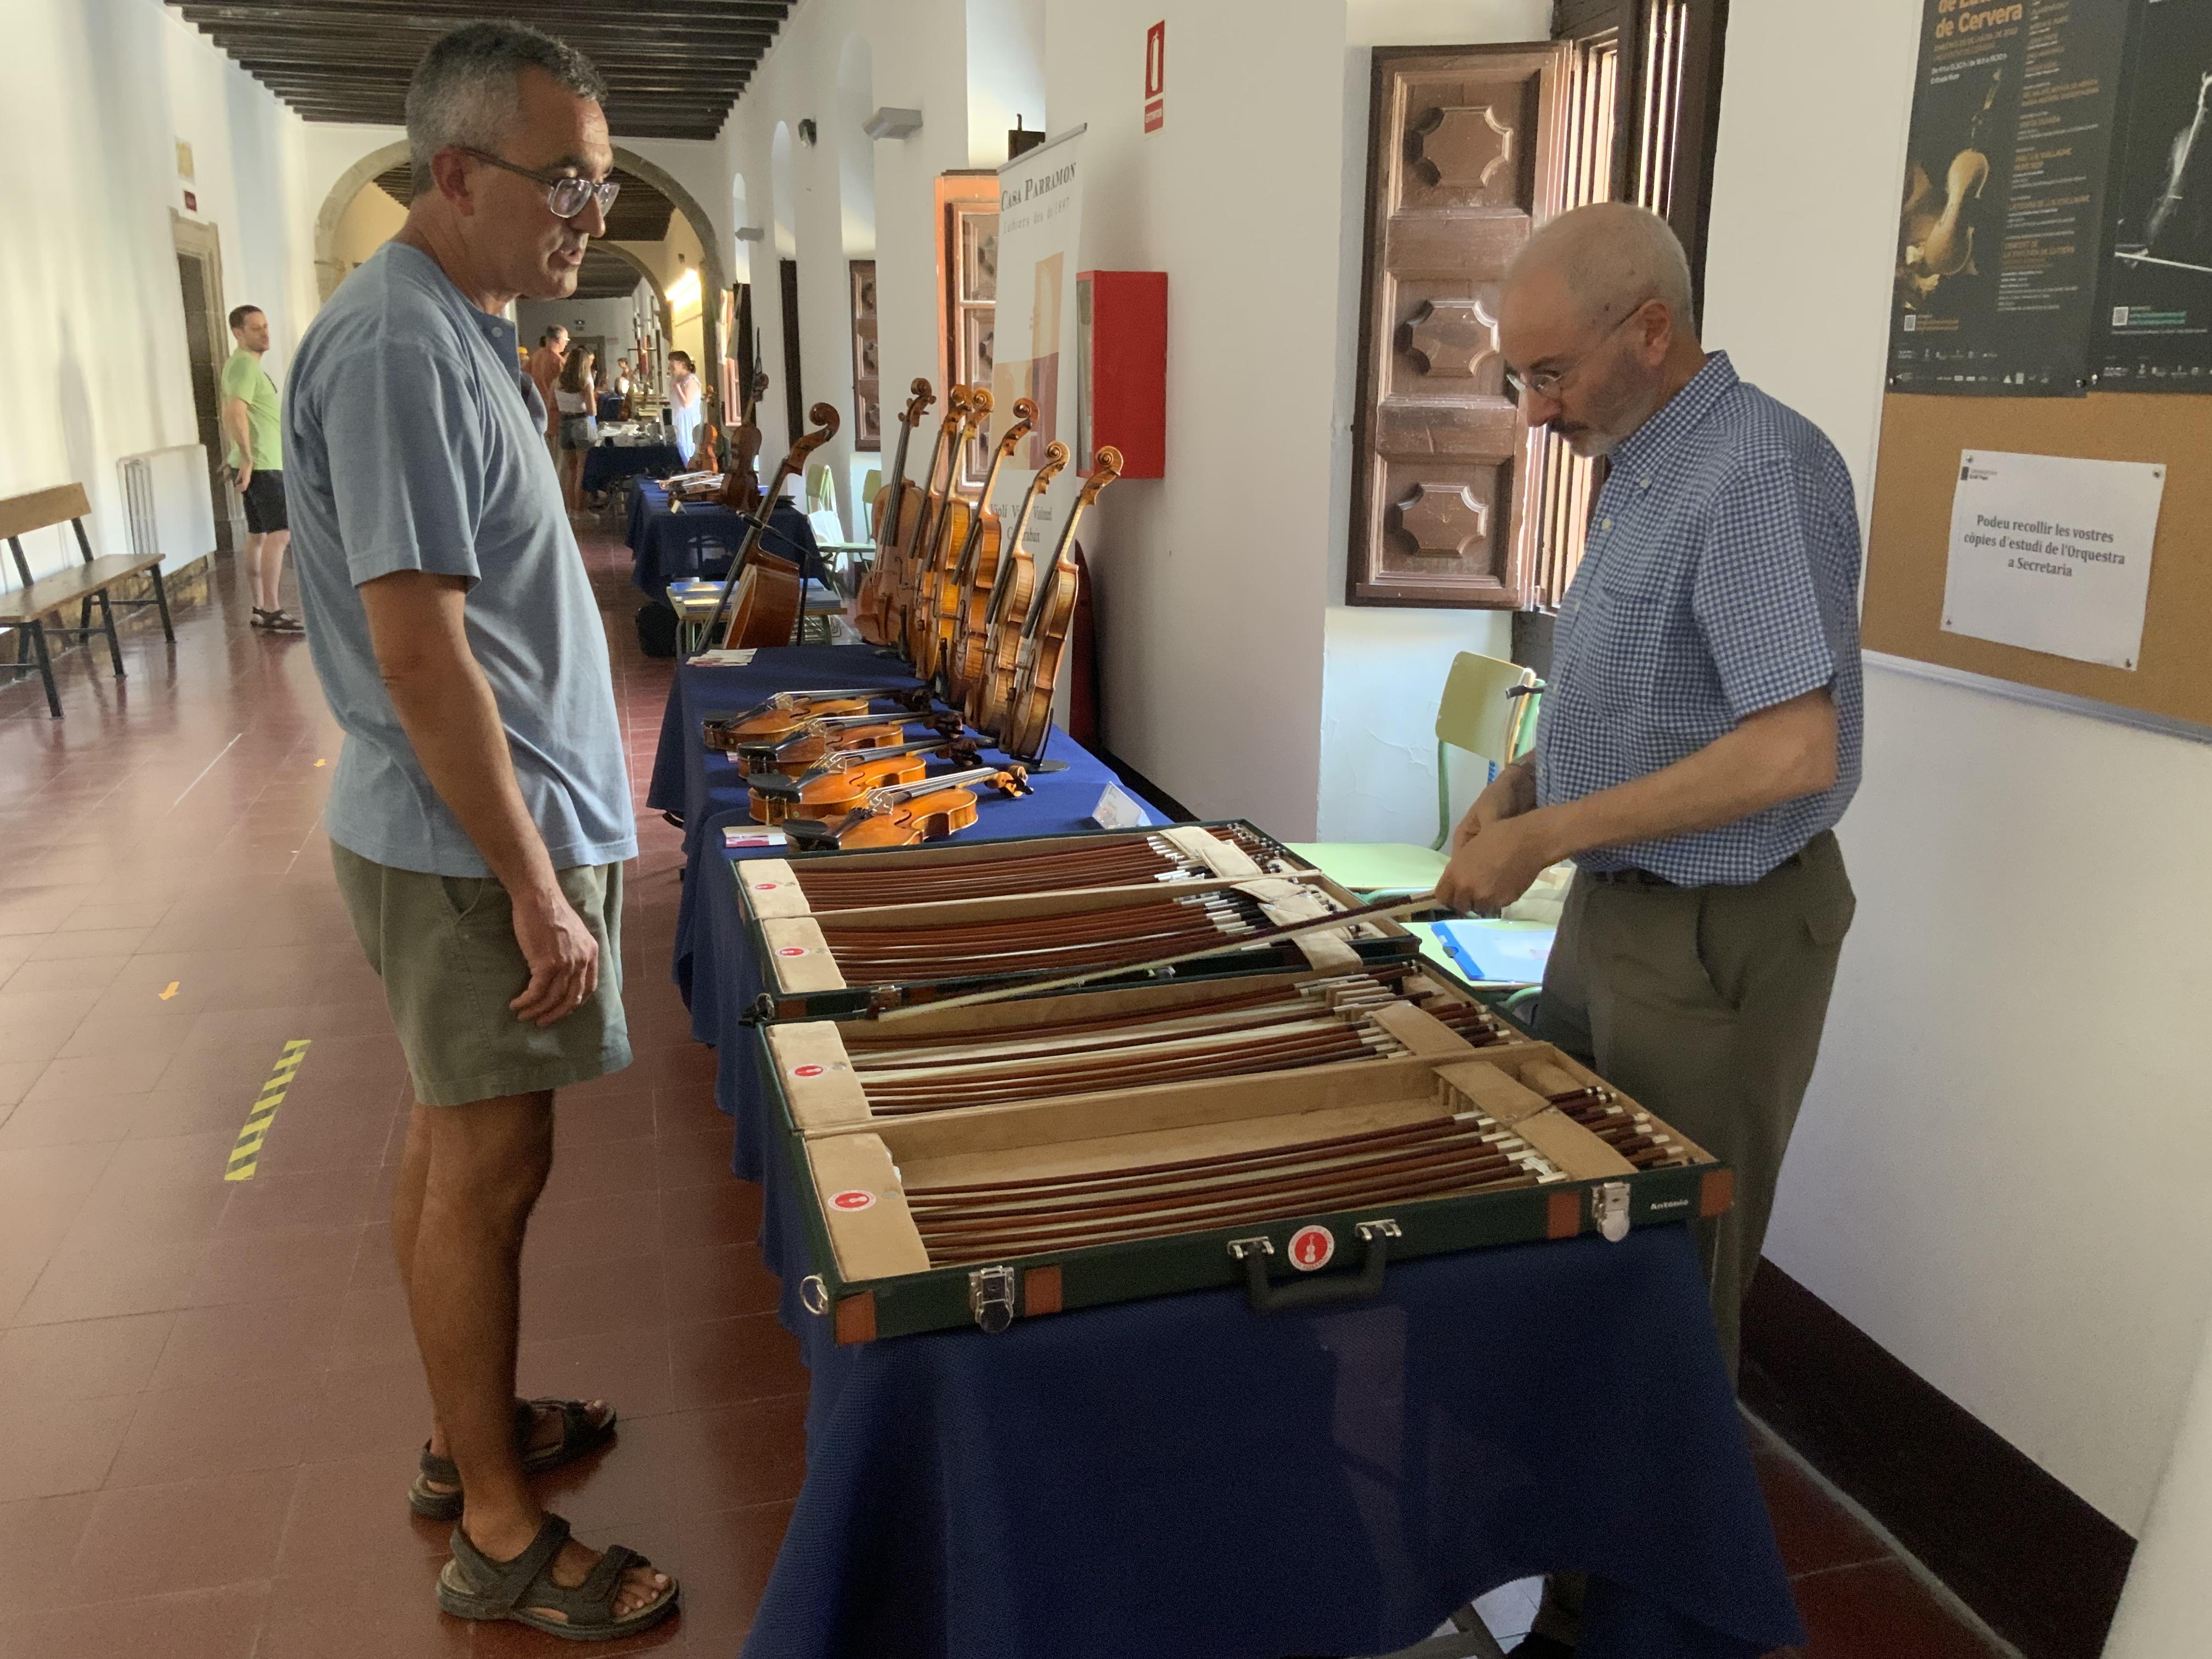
[1347,0,1725,611]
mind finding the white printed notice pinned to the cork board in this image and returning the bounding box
[1942,449,2165,668]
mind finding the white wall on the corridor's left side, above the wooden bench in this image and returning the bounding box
[0,0,314,571]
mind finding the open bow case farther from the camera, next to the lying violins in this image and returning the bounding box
[732,823,1420,1020]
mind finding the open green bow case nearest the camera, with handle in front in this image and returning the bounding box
[759,964,1732,1342]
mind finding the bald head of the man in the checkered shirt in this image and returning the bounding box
[1498,201,1706,456]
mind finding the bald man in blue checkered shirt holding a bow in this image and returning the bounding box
[1438,204,1860,1407]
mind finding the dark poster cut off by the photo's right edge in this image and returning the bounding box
[2095,0,2212,392]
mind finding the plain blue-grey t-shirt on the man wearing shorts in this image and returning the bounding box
[285,241,637,876]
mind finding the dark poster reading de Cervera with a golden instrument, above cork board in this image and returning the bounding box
[1889,0,2126,398]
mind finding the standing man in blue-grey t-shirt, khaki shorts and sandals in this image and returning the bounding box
[285,24,677,1639]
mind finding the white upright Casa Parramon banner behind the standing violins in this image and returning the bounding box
[991,126,1088,560]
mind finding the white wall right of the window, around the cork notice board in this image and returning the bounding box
[1708,0,2212,1531]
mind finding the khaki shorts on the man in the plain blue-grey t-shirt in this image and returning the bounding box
[330,843,630,1106]
